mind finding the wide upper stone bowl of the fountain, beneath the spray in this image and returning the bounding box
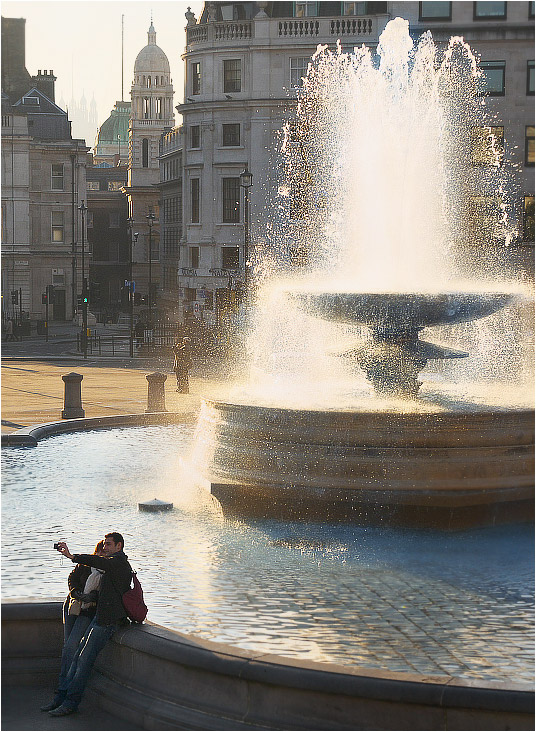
[287,290,514,331]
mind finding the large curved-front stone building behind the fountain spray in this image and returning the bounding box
[166,0,534,320]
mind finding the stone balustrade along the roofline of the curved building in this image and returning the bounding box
[186,15,384,45]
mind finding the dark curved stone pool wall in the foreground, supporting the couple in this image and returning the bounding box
[2,602,534,730]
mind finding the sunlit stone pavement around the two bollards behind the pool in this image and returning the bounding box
[2,324,229,433]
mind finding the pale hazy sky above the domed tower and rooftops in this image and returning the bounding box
[2,0,204,136]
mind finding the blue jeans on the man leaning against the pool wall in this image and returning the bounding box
[56,618,119,709]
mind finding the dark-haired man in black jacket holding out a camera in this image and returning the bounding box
[41,532,132,717]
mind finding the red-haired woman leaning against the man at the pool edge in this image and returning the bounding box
[41,540,105,712]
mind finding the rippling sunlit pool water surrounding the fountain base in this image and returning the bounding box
[2,426,534,683]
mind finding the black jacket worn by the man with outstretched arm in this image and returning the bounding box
[72,551,132,625]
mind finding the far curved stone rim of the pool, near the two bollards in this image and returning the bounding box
[2,412,196,447]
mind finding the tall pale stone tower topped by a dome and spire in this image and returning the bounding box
[126,20,175,318]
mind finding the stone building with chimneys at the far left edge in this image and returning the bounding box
[2,13,89,320]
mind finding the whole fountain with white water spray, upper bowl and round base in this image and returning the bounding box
[188,18,533,529]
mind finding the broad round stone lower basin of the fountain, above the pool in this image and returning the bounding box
[197,400,534,529]
